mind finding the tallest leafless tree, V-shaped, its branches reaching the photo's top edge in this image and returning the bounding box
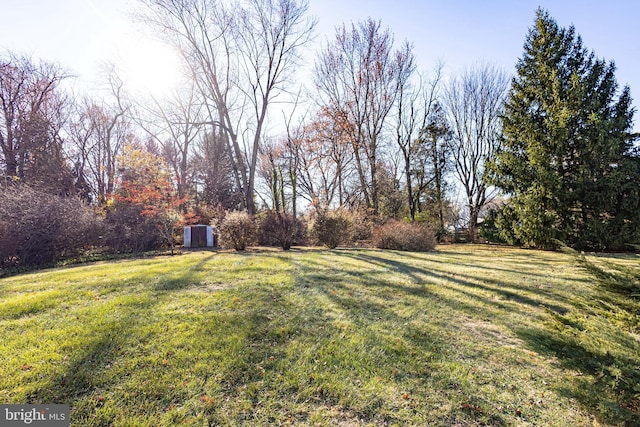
[142,0,315,214]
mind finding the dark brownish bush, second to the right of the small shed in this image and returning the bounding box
[258,211,305,251]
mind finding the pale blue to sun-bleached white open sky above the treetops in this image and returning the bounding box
[0,0,640,129]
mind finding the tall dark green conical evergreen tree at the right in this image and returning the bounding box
[490,9,640,249]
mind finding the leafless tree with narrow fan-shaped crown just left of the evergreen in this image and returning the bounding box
[444,65,509,238]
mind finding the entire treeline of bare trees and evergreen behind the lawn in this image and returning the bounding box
[0,0,640,264]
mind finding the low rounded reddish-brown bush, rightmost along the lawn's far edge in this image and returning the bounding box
[373,221,437,252]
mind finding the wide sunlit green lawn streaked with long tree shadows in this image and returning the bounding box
[0,245,640,426]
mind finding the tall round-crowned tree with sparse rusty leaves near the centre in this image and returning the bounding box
[315,19,413,213]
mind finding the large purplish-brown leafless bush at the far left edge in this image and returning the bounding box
[0,184,102,267]
